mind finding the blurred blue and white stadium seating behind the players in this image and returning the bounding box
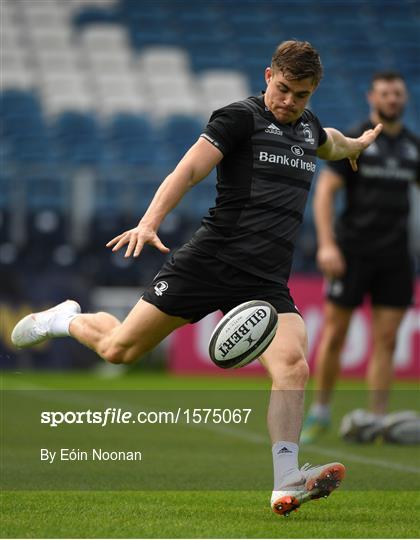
[0,0,420,284]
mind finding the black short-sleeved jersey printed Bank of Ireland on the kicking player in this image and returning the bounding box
[190,96,327,283]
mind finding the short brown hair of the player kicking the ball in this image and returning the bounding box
[271,40,323,85]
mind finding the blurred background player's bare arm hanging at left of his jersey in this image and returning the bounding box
[313,168,346,279]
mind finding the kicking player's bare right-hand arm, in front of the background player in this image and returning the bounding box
[317,124,382,171]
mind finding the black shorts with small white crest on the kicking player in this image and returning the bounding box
[143,245,299,322]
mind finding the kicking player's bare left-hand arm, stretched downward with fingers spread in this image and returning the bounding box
[107,138,223,257]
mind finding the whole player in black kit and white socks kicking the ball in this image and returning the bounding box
[12,41,382,515]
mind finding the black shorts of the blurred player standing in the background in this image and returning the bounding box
[326,251,414,308]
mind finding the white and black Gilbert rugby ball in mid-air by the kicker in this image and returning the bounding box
[209,300,278,369]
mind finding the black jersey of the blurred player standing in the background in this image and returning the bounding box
[328,122,420,257]
